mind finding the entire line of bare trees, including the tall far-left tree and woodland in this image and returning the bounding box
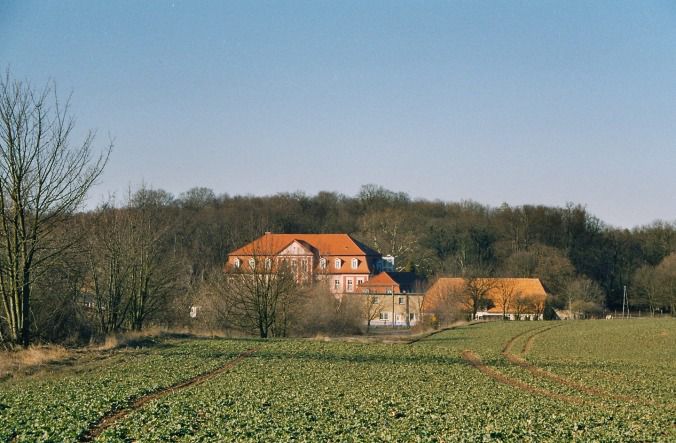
[0,74,676,345]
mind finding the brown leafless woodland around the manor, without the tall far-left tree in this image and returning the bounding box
[10,185,676,346]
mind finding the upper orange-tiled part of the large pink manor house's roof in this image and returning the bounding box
[229,233,380,256]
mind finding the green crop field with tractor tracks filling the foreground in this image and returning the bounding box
[0,319,676,442]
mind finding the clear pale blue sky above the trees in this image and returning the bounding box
[0,0,676,228]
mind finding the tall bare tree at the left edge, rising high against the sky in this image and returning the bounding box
[0,71,110,346]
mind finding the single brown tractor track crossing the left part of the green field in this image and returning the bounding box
[79,349,256,442]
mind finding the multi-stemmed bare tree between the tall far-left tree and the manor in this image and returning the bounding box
[84,187,182,334]
